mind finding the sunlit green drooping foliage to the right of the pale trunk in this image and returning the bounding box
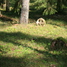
[30,0,57,15]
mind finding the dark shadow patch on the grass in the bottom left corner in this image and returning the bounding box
[0,56,29,67]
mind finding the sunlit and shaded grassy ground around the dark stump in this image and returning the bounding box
[0,16,67,67]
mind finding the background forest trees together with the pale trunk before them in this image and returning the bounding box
[0,0,67,24]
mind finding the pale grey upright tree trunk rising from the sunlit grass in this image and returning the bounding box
[20,0,30,24]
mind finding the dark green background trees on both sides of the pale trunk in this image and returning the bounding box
[0,0,67,15]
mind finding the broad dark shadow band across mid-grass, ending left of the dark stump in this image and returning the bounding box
[0,32,52,45]
